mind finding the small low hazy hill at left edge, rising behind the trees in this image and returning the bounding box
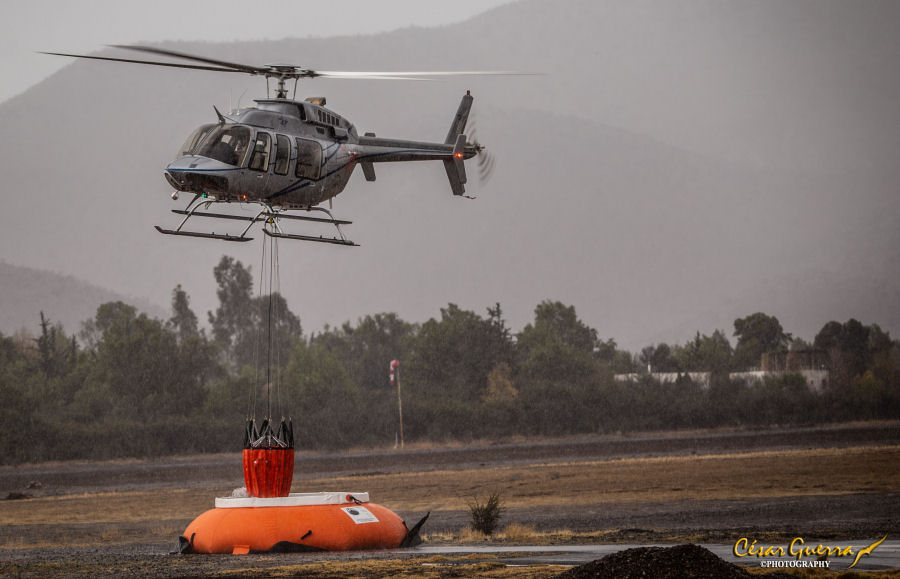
[0,261,166,336]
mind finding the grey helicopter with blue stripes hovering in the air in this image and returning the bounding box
[43,45,534,246]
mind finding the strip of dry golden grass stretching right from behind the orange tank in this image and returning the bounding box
[308,446,900,511]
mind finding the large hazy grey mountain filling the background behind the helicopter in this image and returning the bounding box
[0,0,900,349]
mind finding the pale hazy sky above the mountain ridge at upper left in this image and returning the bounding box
[0,0,511,102]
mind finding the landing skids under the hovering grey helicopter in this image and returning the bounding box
[156,195,357,246]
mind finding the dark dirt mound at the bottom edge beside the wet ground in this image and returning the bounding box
[556,545,784,579]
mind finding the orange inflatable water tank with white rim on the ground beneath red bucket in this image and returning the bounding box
[179,493,424,553]
